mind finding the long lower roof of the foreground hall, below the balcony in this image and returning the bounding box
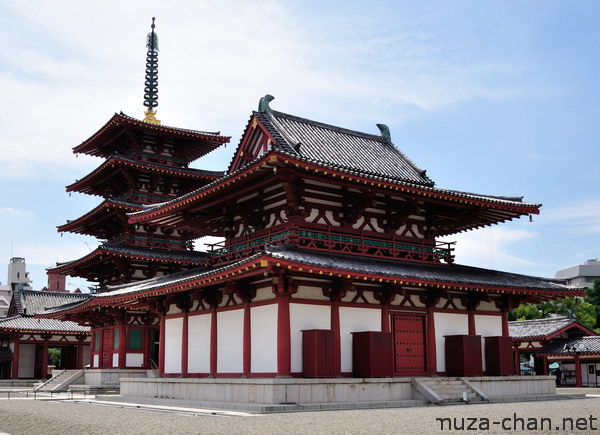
[42,246,584,317]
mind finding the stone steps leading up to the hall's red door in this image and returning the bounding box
[413,377,488,405]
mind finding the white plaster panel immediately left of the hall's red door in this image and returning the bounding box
[340,307,381,372]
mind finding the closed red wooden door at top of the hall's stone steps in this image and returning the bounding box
[394,314,425,374]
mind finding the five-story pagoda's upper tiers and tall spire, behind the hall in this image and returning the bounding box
[49,19,229,291]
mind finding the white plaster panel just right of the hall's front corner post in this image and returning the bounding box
[290,304,331,372]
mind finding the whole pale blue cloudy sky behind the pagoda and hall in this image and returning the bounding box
[0,0,600,289]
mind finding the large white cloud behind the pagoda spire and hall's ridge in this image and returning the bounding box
[0,0,544,177]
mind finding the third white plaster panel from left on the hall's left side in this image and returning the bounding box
[217,309,244,373]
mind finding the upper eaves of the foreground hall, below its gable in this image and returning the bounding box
[129,151,541,235]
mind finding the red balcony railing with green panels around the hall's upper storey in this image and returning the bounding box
[209,227,455,266]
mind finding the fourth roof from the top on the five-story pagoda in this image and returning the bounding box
[47,242,207,275]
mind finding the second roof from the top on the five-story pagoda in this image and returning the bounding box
[67,154,224,194]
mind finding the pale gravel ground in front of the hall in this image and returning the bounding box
[0,398,600,435]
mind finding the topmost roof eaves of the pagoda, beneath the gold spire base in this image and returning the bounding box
[73,113,231,161]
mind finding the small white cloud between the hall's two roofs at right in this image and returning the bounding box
[455,227,541,270]
